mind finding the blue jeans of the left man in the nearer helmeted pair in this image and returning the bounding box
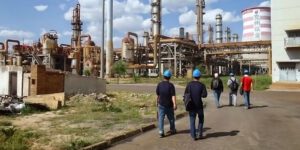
[158,105,176,134]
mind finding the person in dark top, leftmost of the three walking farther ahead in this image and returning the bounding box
[210,73,224,108]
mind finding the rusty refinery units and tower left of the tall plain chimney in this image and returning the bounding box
[0,4,101,76]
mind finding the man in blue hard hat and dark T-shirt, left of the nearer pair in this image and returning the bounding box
[156,70,177,138]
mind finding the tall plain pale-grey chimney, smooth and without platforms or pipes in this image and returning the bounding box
[106,0,114,77]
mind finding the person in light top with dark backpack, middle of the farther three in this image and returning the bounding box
[227,73,239,106]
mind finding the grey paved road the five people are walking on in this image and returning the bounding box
[108,85,300,150]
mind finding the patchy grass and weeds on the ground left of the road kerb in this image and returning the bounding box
[0,92,185,150]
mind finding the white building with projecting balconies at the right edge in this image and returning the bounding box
[271,0,300,84]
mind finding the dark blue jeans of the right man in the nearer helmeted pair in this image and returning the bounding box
[189,109,204,138]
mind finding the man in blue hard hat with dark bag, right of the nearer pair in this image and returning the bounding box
[185,69,207,140]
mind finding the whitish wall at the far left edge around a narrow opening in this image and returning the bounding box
[0,66,23,97]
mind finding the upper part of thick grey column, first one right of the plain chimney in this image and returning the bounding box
[151,0,161,37]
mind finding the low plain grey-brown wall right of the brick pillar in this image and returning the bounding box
[65,74,106,97]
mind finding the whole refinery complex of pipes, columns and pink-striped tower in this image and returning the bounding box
[0,0,278,95]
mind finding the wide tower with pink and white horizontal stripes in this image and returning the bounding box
[242,7,271,41]
